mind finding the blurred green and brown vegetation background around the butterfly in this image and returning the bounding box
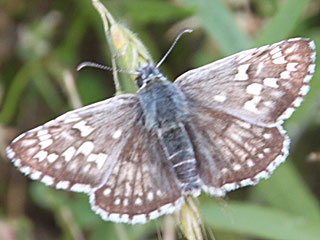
[0,0,320,240]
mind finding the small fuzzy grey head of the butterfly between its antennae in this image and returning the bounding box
[136,62,164,88]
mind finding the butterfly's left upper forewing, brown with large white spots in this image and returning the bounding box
[7,95,141,192]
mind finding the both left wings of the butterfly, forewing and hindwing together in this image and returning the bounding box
[7,95,183,224]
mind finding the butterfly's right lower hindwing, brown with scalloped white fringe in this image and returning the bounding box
[186,107,289,196]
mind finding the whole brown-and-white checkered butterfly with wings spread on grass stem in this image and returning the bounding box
[7,34,316,224]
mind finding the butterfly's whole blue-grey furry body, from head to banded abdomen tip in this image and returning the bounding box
[137,63,199,194]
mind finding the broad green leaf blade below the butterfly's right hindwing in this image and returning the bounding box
[201,202,320,240]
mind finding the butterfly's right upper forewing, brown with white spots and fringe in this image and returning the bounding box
[174,38,316,126]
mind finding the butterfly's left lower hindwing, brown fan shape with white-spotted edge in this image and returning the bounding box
[90,127,183,224]
